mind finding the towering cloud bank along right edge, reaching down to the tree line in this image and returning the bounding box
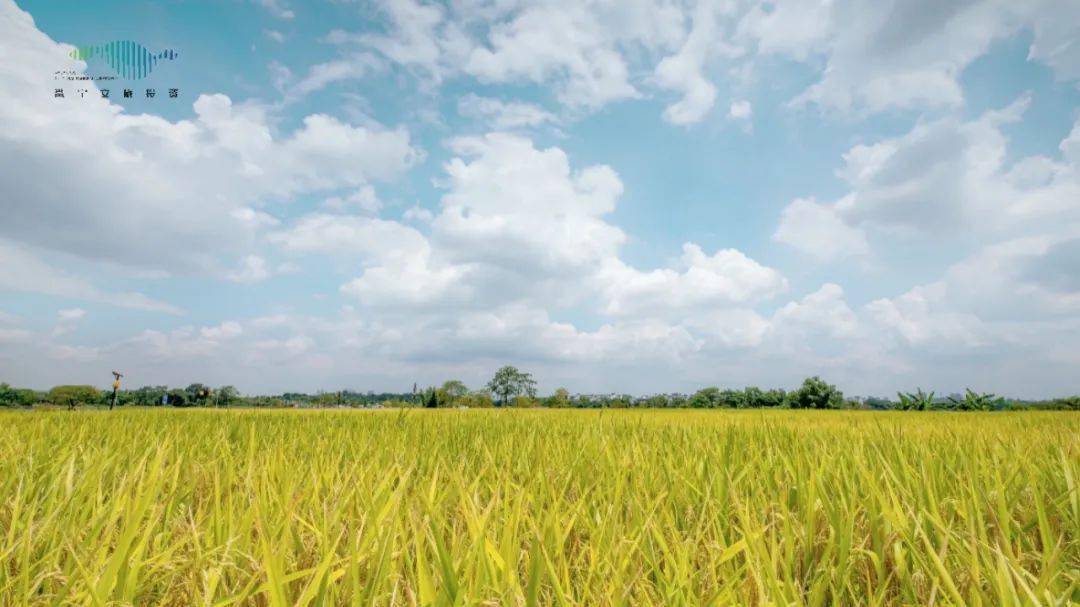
[773,97,1080,393]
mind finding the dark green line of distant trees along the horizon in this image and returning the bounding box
[0,366,1080,410]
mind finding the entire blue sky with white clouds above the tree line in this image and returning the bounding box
[0,0,1080,397]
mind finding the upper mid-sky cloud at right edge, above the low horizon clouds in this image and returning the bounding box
[773,96,1080,260]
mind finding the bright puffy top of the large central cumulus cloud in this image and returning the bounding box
[432,133,625,278]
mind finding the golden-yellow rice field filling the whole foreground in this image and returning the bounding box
[0,409,1080,606]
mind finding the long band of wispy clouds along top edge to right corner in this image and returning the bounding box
[257,0,1080,129]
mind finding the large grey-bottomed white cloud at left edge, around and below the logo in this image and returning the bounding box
[0,0,419,272]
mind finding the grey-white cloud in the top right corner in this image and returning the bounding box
[739,0,1080,112]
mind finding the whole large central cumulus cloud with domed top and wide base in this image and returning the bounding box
[263,133,787,380]
